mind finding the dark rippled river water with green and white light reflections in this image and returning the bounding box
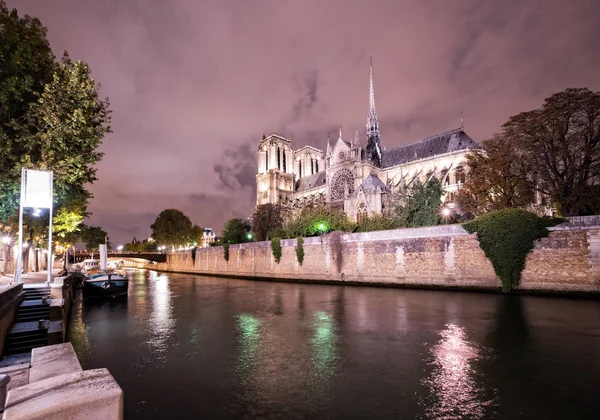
[70,271,600,419]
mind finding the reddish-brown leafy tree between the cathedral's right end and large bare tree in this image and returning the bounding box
[456,134,533,216]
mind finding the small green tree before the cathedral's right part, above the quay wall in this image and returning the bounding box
[396,178,443,227]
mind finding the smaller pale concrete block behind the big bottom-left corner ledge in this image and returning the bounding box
[29,342,81,383]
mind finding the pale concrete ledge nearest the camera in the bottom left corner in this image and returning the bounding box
[3,369,123,420]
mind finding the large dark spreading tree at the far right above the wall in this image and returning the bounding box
[502,88,600,216]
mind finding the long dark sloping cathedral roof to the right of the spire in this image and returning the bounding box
[381,128,479,168]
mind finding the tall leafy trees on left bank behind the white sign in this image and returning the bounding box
[0,0,111,226]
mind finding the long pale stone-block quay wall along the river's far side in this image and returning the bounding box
[159,218,600,294]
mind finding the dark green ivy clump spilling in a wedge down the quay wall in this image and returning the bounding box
[463,209,563,292]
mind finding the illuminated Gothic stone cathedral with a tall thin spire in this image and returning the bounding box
[256,60,479,222]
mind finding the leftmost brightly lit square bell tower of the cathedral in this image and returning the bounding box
[256,134,294,206]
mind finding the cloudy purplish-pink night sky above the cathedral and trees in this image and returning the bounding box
[7,0,600,243]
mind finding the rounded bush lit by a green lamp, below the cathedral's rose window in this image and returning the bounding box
[287,207,356,238]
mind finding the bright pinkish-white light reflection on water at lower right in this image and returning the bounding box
[424,324,492,419]
